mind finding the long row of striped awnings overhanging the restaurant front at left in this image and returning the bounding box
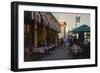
[24,11,60,32]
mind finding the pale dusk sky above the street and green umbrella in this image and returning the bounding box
[52,12,90,30]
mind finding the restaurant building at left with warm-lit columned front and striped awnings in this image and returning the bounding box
[24,11,61,59]
